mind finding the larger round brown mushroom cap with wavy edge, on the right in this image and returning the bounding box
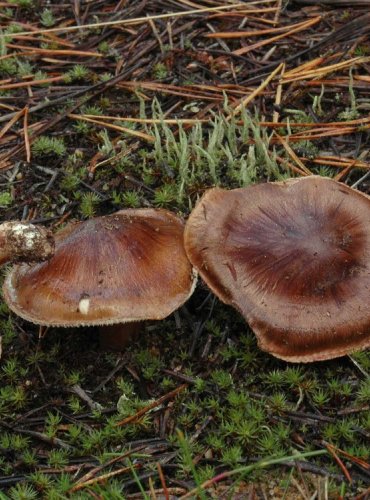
[185,176,370,362]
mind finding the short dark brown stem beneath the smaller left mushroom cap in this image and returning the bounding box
[99,321,143,351]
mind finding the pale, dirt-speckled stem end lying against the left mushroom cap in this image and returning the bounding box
[0,221,54,265]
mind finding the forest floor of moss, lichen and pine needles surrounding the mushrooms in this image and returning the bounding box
[0,0,370,500]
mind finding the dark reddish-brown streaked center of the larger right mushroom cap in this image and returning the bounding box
[226,199,366,302]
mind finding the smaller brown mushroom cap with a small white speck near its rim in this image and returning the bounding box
[4,209,195,326]
